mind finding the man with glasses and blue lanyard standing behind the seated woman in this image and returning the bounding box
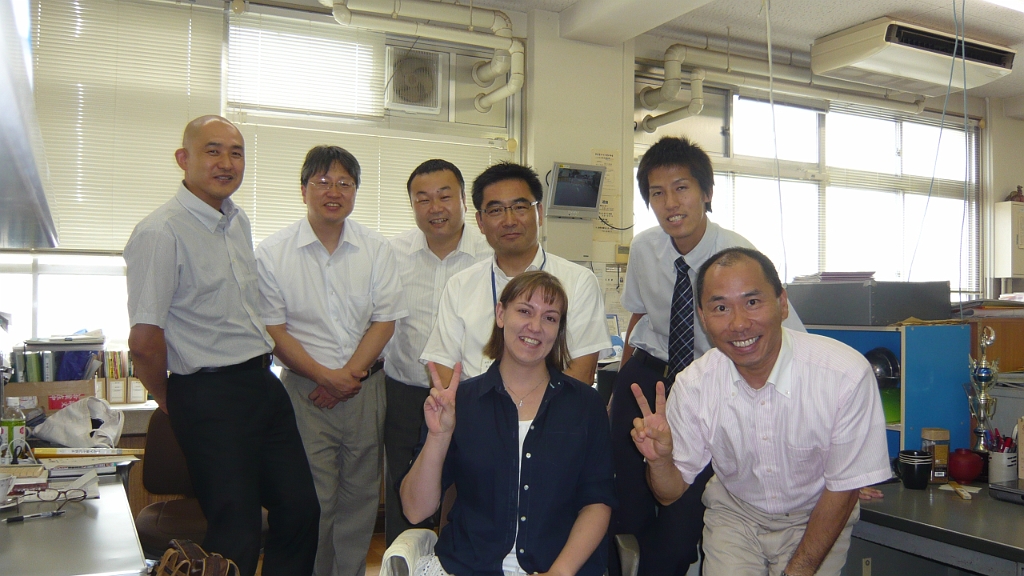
[420,162,611,383]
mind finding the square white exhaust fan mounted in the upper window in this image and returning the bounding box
[385,46,446,115]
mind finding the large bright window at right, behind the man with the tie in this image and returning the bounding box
[634,97,981,299]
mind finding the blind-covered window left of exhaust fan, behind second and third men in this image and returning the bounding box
[227,6,512,244]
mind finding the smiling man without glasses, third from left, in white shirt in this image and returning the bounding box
[384,159,493,545]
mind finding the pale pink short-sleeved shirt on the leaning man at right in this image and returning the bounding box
[666,329,892,513]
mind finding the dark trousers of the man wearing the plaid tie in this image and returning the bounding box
[609,356,714,576]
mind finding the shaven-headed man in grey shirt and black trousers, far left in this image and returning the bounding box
[124,116,319,576]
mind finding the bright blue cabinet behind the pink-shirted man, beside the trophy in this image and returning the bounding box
[807,324,971,457]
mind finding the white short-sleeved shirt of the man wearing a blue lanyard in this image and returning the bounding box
[420,248,612,380]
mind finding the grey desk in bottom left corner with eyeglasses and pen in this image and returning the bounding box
[0,477,145,576]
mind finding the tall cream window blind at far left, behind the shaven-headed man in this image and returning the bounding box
[32,0,223,250]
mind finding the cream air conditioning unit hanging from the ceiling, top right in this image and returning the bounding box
[811,17,1017,96]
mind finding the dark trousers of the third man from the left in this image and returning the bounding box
[384,375,436,546]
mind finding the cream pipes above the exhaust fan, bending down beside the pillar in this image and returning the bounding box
[319,0,526,107]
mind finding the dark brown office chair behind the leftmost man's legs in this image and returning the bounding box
[135,409,267,560]
